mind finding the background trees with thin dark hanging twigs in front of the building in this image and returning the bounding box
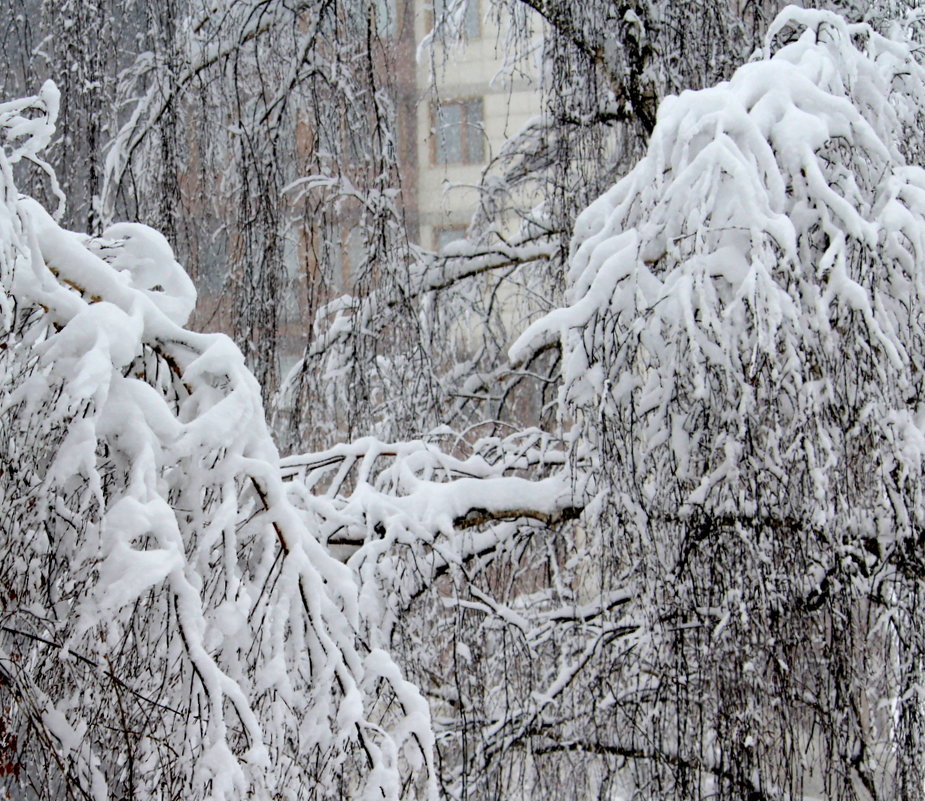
[2,0,796,448]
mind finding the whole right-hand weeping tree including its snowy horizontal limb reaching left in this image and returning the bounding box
[268,8,925,799]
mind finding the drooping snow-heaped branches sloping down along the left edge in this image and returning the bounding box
[0,84,432,801]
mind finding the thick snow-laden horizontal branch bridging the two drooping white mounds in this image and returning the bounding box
[282,430,587,564]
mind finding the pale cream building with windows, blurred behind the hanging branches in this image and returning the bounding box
[192,0,540,375]
